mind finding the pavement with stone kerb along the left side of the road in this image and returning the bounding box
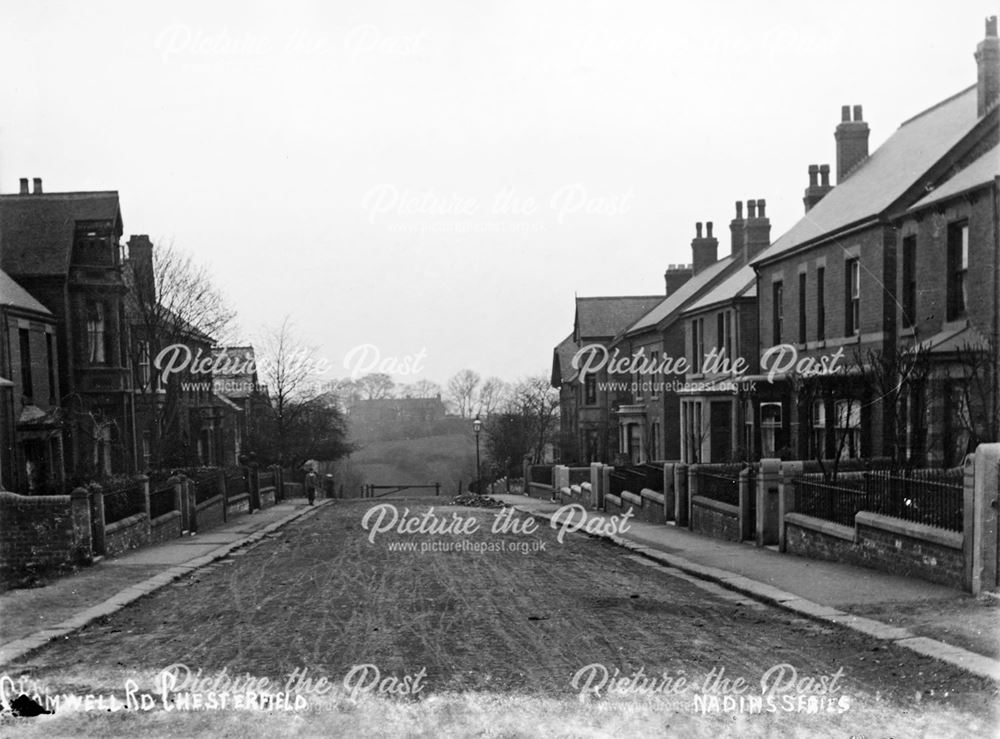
[0,498,332,665]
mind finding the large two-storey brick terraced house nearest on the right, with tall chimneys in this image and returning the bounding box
[753,17,1000,465]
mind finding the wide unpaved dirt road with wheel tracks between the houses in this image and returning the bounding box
[0,499,997,737]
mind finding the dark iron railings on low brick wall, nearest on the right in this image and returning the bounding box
[793,467,964,531]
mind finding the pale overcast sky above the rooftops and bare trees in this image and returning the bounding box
[0,0,996,384]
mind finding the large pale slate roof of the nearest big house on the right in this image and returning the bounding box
[751,85,979,264]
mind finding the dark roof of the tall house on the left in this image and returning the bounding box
[0,190,121,275]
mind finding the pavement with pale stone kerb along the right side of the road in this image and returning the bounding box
[492,495,1000,681]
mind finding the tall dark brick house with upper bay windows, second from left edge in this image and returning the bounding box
[0,178,135,477]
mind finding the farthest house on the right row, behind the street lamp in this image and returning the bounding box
[551,295,663,462]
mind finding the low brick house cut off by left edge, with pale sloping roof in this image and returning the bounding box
[0,272,65,494]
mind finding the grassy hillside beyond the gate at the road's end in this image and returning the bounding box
[335,433,476,495]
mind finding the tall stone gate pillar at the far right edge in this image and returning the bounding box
[963,443,1000,595]
